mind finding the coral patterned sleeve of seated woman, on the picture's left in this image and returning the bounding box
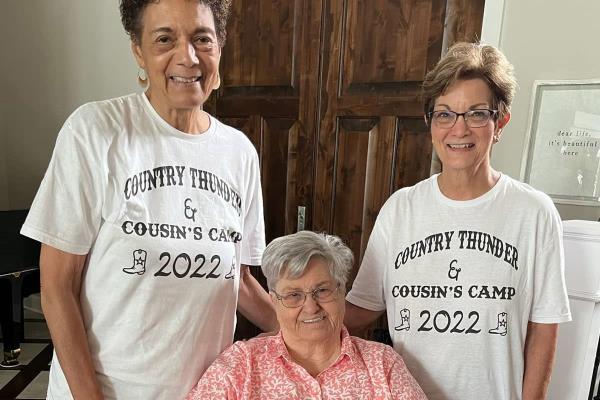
[186,343,247,400]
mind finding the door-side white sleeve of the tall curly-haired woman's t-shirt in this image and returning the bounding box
[241,147,265,265]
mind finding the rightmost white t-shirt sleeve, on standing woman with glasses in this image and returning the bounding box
[529,206,571,324]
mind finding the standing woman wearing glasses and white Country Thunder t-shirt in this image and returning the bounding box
[345,43,571,400]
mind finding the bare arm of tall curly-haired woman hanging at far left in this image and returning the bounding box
[40,245,103,400]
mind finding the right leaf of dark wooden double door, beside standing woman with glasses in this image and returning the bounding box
[313,0,484,285]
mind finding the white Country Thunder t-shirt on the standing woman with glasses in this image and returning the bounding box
[347,175,571,400]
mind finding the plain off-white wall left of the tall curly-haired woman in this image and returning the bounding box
[0,0,139,209]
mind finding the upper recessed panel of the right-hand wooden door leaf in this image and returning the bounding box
[340,0,446,96]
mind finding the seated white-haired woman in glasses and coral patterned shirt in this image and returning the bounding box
[188,231,426,400]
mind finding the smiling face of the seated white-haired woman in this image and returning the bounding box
[271,257,345,347]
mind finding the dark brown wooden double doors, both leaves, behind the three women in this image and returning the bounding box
[216,0,484,337]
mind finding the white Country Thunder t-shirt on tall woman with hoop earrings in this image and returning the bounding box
[21,94,264,400]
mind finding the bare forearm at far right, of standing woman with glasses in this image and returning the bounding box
[523,322,558,400]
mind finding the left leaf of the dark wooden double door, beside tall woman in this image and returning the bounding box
[216,0,320,338]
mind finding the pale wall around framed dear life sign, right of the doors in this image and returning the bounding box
[484,0,600,220]
